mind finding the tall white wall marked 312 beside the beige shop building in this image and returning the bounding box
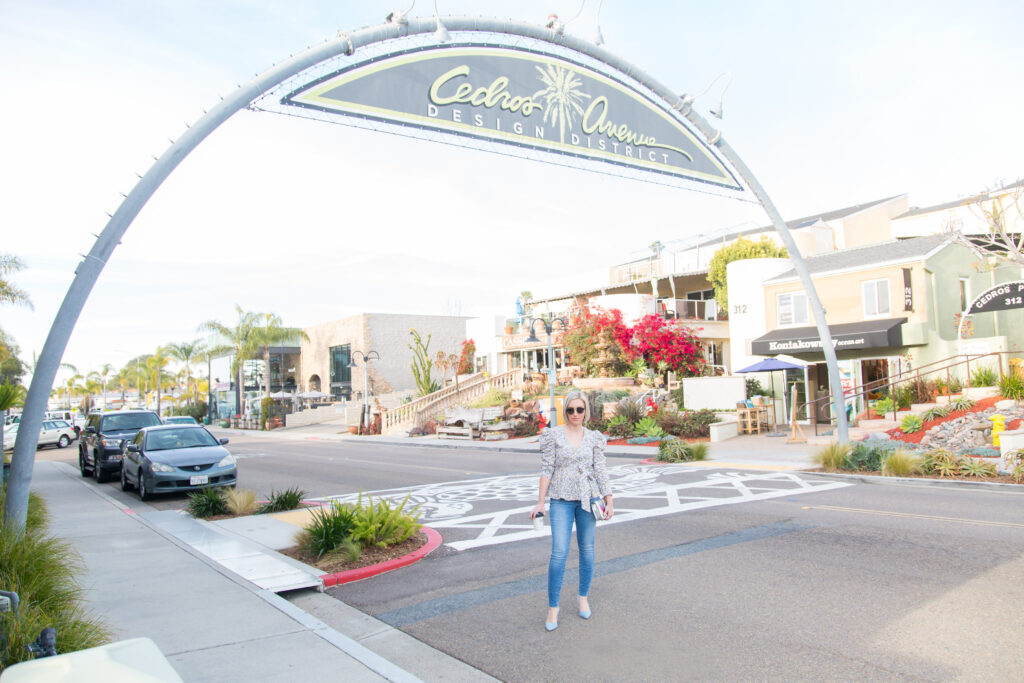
[725,258,793,372]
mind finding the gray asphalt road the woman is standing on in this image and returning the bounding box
[40,437,1024,681]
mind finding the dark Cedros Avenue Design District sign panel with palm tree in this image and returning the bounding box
[282,44,742,190]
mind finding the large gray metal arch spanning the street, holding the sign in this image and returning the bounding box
[4,16,848,530]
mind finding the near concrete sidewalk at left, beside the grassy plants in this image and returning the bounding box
[32,462,494,682]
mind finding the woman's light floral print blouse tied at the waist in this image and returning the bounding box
[538,427,611,502]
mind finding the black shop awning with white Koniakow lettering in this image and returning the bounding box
[751,317,906,355]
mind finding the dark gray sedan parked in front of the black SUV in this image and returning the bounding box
[121,425,238,501]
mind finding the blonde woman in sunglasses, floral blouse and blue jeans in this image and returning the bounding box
[529,391,614,631]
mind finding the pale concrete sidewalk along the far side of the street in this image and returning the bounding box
[209,423,821,470]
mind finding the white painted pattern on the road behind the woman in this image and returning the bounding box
[318,465,852,550]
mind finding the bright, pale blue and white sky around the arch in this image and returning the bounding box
[0,0,1024,379]
